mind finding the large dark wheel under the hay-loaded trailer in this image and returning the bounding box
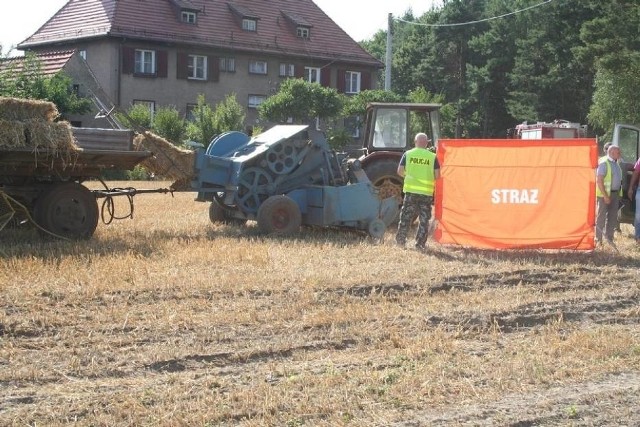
[33,182,98,239]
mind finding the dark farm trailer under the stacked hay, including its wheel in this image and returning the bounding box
[0,128,154,239]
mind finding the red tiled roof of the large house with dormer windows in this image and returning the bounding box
[18,0,382,68]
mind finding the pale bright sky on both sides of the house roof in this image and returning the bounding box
[0,0,433,56]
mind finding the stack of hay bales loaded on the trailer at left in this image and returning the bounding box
[0,97,78,154]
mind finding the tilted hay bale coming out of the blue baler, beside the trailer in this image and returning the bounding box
[133,132,195,185]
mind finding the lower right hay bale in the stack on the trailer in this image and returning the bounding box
[24,119,78,152]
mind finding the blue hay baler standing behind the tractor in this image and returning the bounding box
[191,125,398,238]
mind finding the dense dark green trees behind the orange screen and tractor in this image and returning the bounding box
[362,0,640,137]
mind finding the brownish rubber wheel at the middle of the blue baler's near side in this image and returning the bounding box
[258,196,302,235]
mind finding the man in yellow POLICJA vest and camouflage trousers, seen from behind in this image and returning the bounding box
[396,133,440,250]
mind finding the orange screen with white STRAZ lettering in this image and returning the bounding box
[435,139,598,250]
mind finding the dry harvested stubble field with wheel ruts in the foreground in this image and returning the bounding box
[0,183,640,427]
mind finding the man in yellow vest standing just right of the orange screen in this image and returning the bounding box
[596,145,623,246]
